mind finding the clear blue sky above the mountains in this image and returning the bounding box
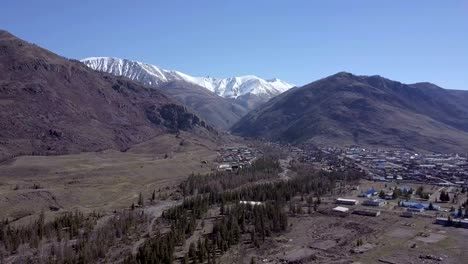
[0,0,468,89]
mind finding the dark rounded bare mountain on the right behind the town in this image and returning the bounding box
[232,73,468,152]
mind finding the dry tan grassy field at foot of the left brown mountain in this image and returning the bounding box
[0,134,216,222]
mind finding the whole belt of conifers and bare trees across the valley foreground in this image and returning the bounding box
[0,157,362,263]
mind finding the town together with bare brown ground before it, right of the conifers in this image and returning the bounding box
[214,143,468,263]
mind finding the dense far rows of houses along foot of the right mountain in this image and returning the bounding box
[292,145,468,187]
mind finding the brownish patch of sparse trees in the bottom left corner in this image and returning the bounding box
[0,210,148,263]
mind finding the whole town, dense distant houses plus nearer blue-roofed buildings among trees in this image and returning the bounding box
[291,144,468,223]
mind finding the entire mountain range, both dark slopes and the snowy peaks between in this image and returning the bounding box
[0,28,468,155]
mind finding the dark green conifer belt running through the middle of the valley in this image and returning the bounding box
[125,158,362,263]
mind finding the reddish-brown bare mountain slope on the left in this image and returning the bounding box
[0,31,216,159]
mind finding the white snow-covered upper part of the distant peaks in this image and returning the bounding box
[81,57,294,100]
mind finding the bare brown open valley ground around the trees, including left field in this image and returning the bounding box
[0,142,468,264]
